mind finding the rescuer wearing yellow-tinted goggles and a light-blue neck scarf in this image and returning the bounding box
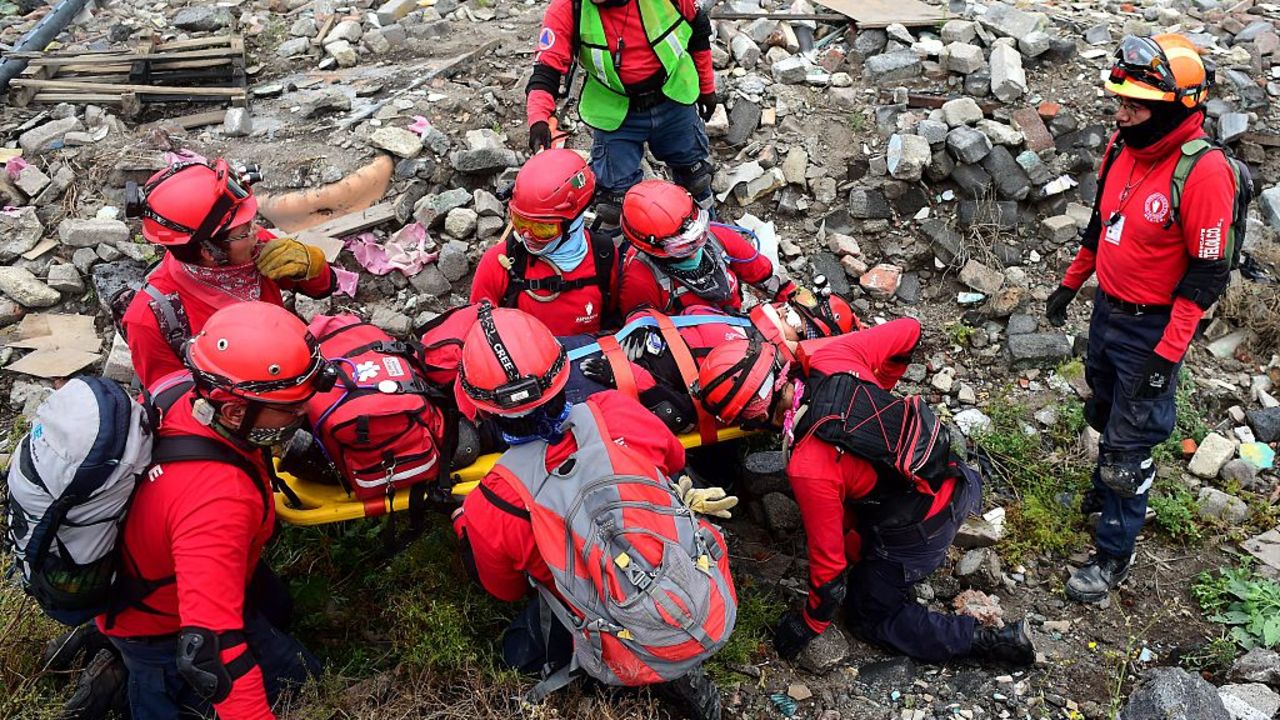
[471,149,618,336]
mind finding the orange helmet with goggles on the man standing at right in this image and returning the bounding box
[1105,33,1213,108]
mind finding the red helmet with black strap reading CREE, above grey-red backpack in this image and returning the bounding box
[458,304,570,418]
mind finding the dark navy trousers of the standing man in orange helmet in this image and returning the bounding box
[1084,293,1181,557]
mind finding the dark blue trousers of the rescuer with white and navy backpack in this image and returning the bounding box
[111,611,321,720]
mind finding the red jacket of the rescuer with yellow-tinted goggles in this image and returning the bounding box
[470,231,617,336]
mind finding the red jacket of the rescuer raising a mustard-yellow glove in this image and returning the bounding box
[123,229,334,387]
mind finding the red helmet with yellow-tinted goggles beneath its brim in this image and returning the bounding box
[507,147,595,254]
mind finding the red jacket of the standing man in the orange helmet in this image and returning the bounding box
[1062,113,1239,363]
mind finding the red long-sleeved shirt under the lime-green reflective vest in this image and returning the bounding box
[525,0,716,126]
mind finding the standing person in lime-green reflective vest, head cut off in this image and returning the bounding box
[525,0,716,240]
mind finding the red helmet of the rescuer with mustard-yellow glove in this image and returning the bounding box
[138,160,257,245]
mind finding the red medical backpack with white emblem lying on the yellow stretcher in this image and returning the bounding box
[307,314,449,502]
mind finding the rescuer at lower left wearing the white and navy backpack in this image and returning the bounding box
[97,301,329,720]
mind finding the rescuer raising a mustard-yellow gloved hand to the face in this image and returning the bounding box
[122,160,337,387]
